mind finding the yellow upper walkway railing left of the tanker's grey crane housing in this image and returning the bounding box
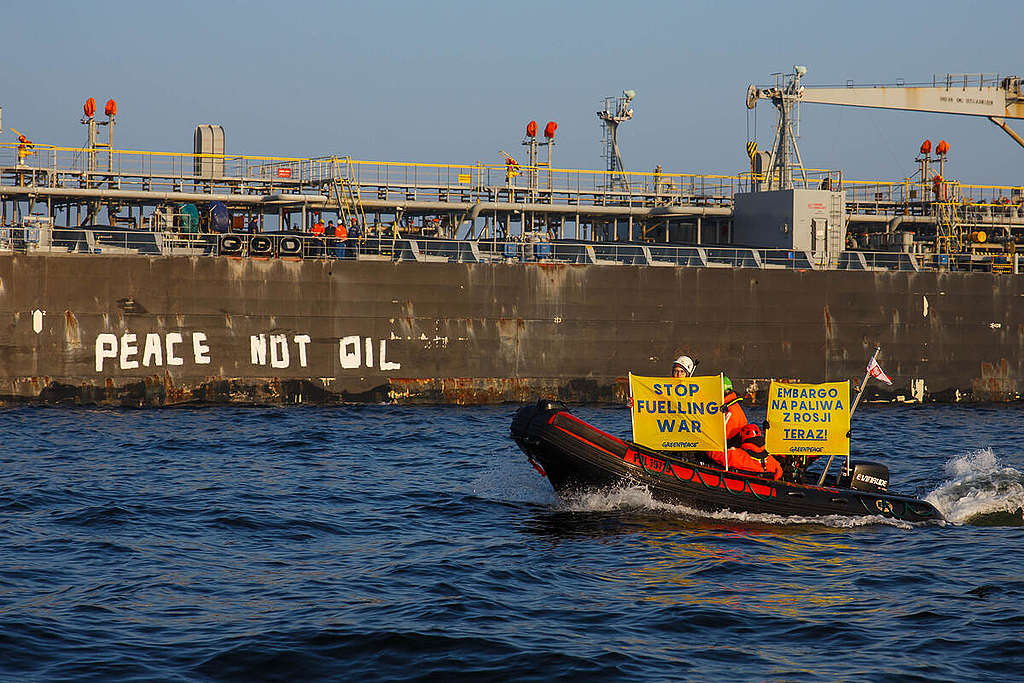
[0,143,741,205]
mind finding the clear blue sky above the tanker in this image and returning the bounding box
[0,0,1024,184]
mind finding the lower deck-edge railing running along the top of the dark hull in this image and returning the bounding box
[0,221,1020,273]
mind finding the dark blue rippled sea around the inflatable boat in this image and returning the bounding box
[0,404,1024,681]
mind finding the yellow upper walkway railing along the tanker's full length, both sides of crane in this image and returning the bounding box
[0,142,1024,210]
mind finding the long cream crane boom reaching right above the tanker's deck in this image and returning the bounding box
[746,68,1024,147]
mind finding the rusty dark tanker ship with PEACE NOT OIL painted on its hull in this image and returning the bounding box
[0,68,1024,405]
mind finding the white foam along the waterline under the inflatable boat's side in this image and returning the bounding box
[559,484,916,528]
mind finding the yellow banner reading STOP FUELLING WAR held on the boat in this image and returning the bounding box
[630,373,725,451]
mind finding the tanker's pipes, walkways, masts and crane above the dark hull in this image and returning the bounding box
[0,67,1024,266]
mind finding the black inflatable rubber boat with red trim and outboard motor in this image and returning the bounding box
[511,399,942,522]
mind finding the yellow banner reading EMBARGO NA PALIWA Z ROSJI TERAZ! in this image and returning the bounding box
[765,381,850,456]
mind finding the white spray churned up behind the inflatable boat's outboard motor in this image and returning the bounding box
[925,449,1024,526]
